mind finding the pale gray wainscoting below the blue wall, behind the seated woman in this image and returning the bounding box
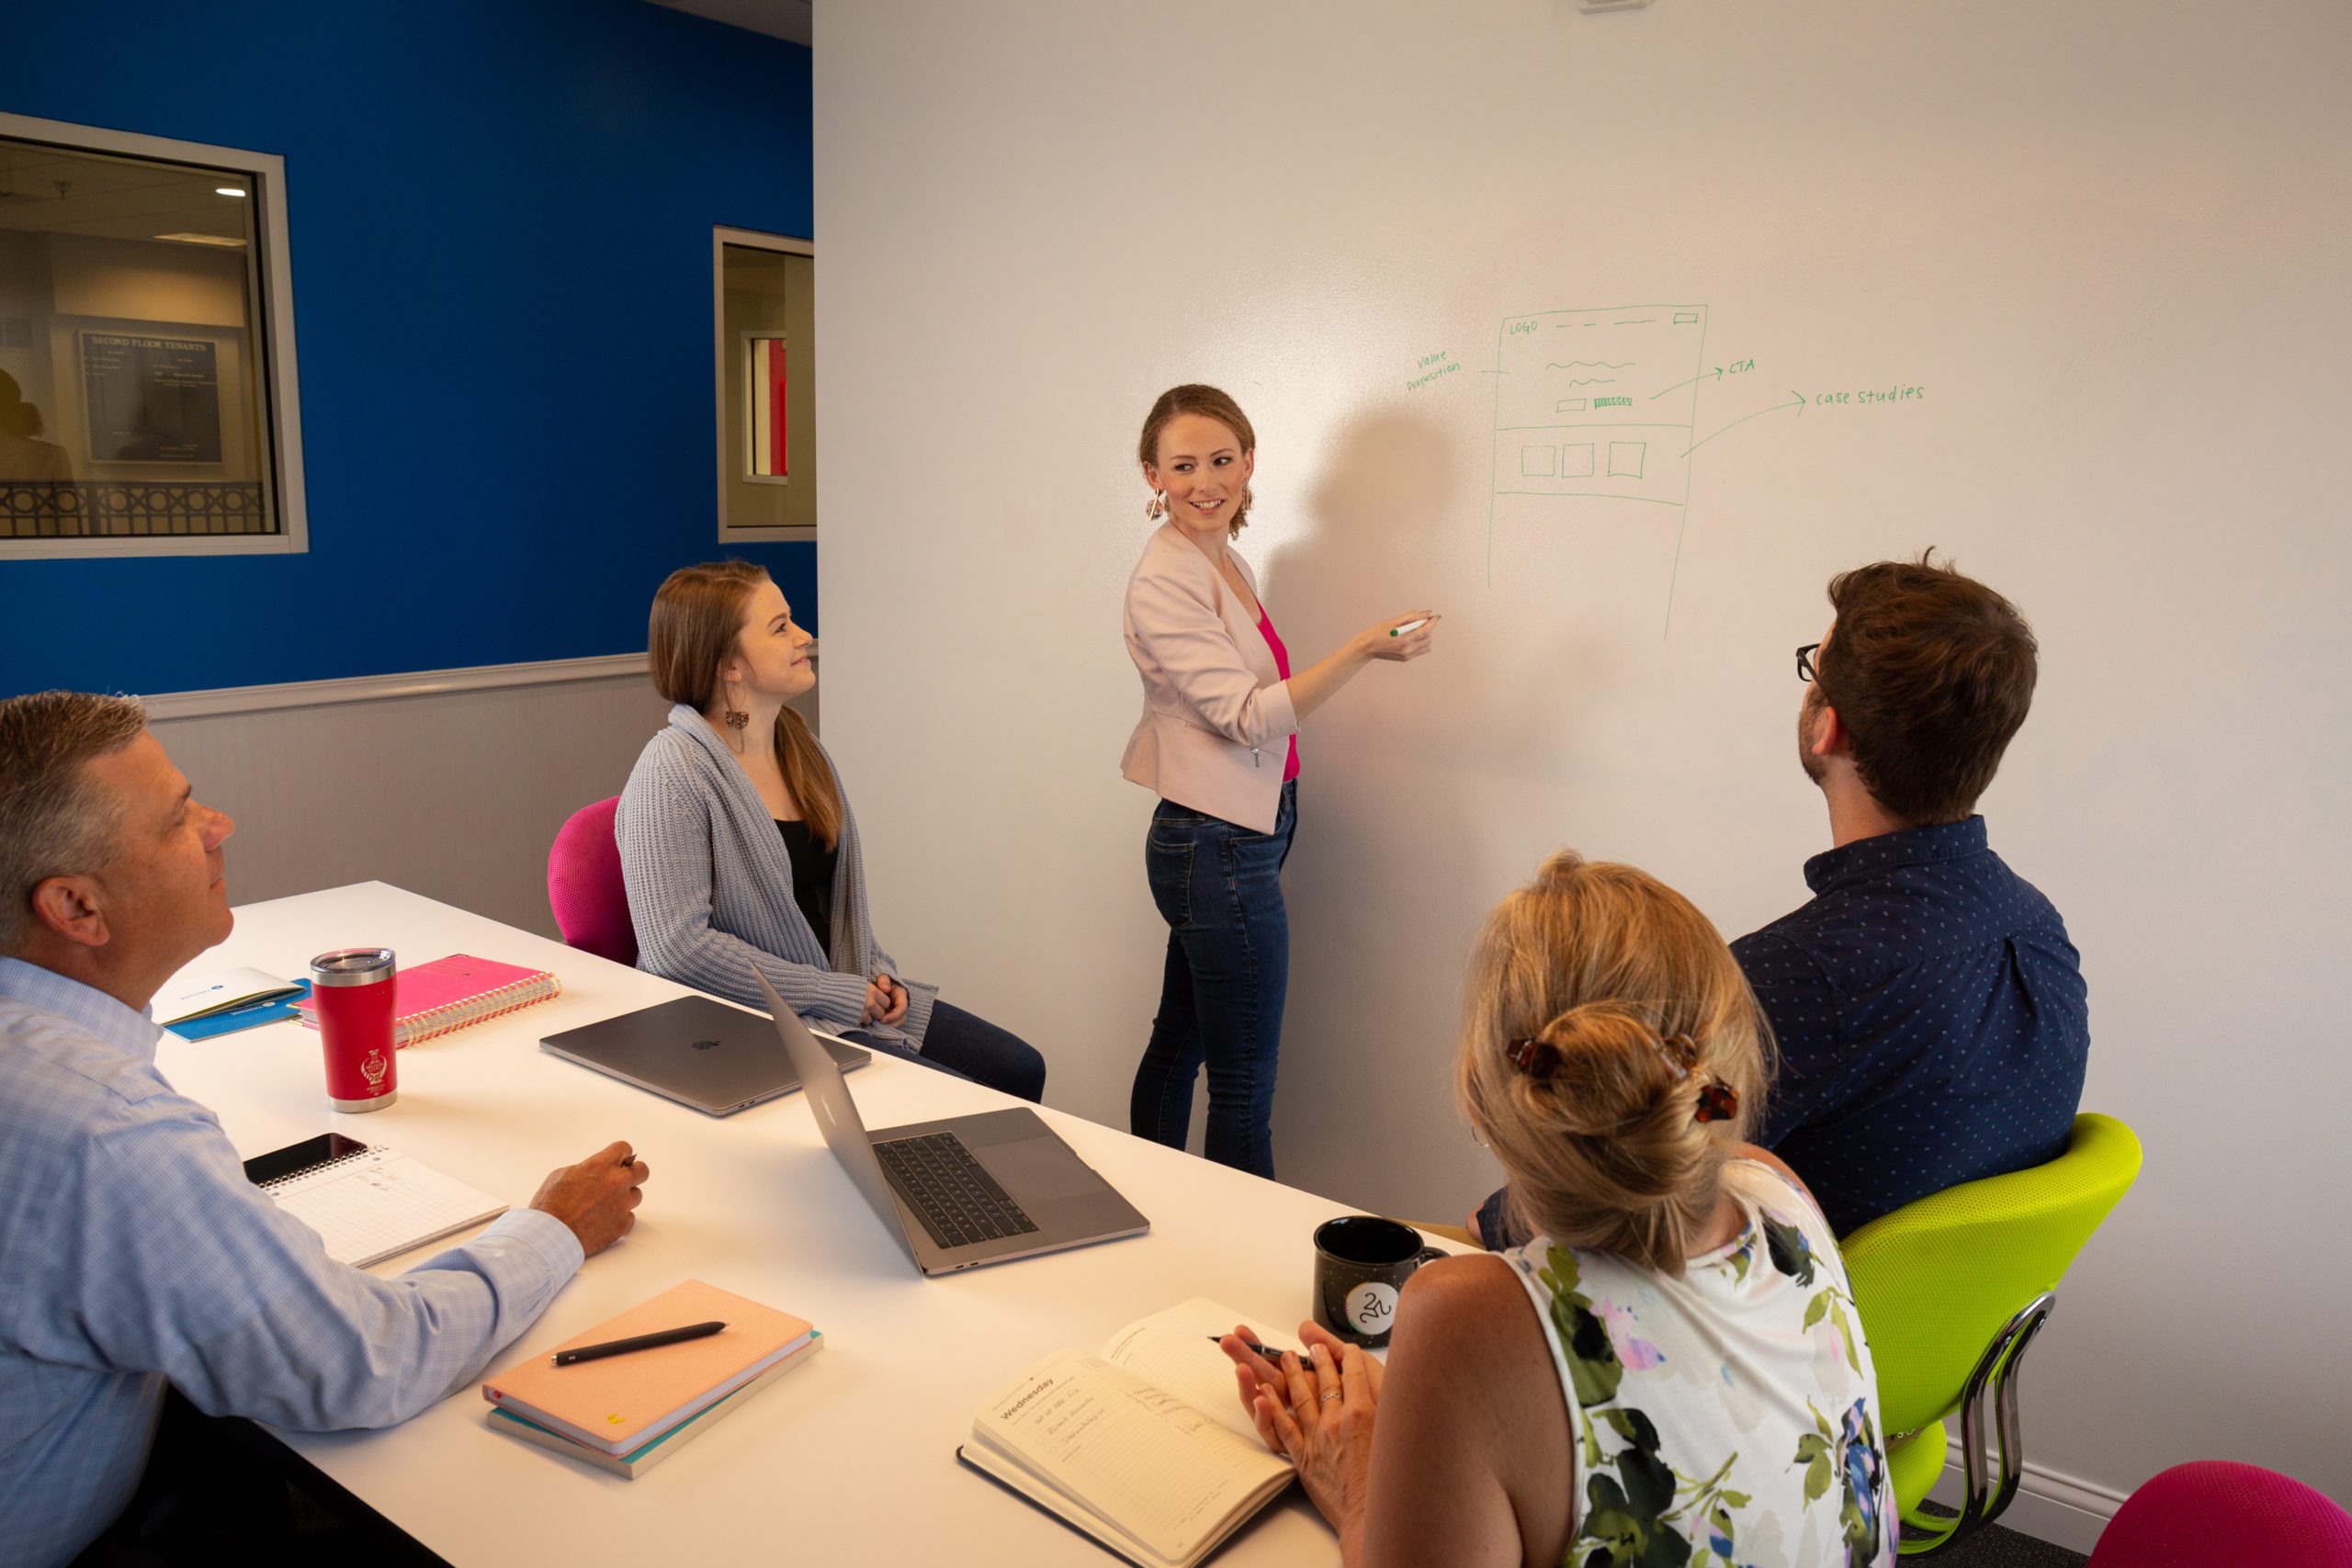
[146,653,816,940]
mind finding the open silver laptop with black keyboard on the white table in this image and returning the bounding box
[752,971,1152,1274]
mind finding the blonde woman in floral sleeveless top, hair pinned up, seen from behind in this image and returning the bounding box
[1223,853,1895,1568]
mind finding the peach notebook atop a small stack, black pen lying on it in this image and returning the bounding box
[482,1279,814,1453]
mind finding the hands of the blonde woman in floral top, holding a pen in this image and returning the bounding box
[1218,1321,1381,1538]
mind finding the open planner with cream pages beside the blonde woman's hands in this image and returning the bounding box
[957,1298,1296,1568]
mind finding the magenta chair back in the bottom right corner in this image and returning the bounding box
[2091,1460,2352,1568]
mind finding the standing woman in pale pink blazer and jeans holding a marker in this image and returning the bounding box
[1120,386,1435,1176]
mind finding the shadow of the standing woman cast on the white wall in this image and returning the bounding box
[1261,407,1503,1215]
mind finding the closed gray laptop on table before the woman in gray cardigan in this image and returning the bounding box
[538,997,873,1117]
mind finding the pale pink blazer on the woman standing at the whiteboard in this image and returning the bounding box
[1120,522,1298,832]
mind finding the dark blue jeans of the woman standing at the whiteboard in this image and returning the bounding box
[1126,778,1298,1178]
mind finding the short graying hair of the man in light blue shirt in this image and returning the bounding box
[0,691,146,954]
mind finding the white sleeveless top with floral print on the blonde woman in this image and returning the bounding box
[1503,1159,1898,1568]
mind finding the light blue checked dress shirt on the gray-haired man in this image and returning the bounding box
[0,957,581,1563]
